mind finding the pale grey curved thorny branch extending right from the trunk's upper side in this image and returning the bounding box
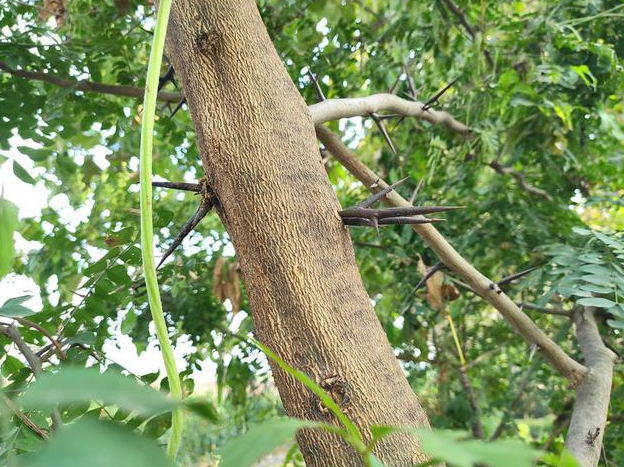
[308,94,470,134]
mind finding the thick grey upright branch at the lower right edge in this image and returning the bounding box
[565,307,616,467]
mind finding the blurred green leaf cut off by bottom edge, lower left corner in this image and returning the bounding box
[18,417,173,467]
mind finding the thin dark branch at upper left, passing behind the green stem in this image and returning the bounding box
[0,61,182,102]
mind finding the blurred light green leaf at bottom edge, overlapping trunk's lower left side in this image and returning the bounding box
[219,418,314,467]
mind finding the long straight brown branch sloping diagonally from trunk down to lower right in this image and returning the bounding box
[315,121,588,387]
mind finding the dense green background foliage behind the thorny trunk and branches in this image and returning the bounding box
[0,0,624,465]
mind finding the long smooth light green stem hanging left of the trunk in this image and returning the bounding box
[139,0,182,459]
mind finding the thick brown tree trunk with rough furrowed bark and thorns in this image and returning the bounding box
[167,0,428,467]
